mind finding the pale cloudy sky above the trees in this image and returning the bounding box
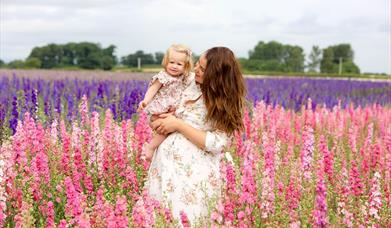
[0,0,391,74]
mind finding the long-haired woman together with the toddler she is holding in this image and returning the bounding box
[139,45,246,223]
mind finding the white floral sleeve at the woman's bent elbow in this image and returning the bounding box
[205,130,228,154]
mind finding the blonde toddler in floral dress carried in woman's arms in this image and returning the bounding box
[137,44,193,160]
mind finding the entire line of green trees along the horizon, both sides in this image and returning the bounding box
[0,41,360,74]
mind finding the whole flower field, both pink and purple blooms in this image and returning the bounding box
[0,71,391,227]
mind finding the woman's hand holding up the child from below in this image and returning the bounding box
[151,113,181,135]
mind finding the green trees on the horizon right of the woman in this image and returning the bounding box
[240,41,360,74]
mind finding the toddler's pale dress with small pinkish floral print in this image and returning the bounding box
[144,71,184,115]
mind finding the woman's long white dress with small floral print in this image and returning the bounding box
[145,74,228,221]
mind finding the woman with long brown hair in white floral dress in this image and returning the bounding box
[145,47,246,221]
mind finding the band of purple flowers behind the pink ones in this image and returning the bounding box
[0,72,391,142]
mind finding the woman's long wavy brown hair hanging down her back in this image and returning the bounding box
[201,47,246,134]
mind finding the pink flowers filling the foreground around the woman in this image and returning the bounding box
[0,97,391,227]
